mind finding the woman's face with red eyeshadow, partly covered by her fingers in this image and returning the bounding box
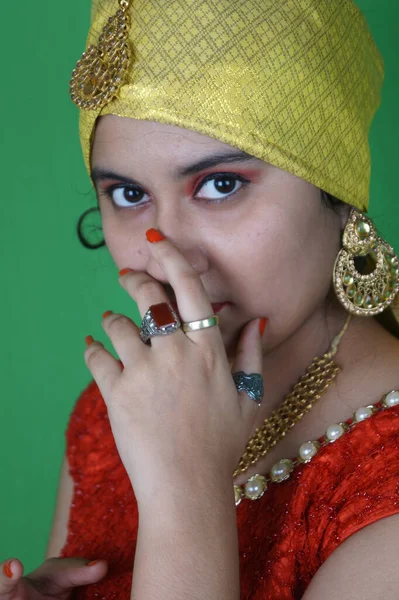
[92,115,342,355]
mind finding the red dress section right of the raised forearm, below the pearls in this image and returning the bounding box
[237,390,399,598]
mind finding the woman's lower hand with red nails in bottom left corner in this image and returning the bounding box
[0,558,108,600]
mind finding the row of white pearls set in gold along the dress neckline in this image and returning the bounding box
[234,390,399,506]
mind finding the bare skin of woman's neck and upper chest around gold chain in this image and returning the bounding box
[235,306,399,483]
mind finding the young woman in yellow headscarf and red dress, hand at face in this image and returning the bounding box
[0,0,399,600]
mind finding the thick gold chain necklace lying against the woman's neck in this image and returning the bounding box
[233,315,351,478]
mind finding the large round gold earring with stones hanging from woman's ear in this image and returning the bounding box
[333,208,399,317]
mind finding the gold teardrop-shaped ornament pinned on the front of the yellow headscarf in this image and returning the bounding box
[70,0,131,110]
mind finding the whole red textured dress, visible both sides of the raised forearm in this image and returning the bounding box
[59,382,399,600]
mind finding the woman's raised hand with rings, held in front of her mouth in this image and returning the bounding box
[85,230,262,502]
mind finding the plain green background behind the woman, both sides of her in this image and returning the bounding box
[0,0,399,573]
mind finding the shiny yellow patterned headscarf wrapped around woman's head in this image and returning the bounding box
[76,0,384,211]
